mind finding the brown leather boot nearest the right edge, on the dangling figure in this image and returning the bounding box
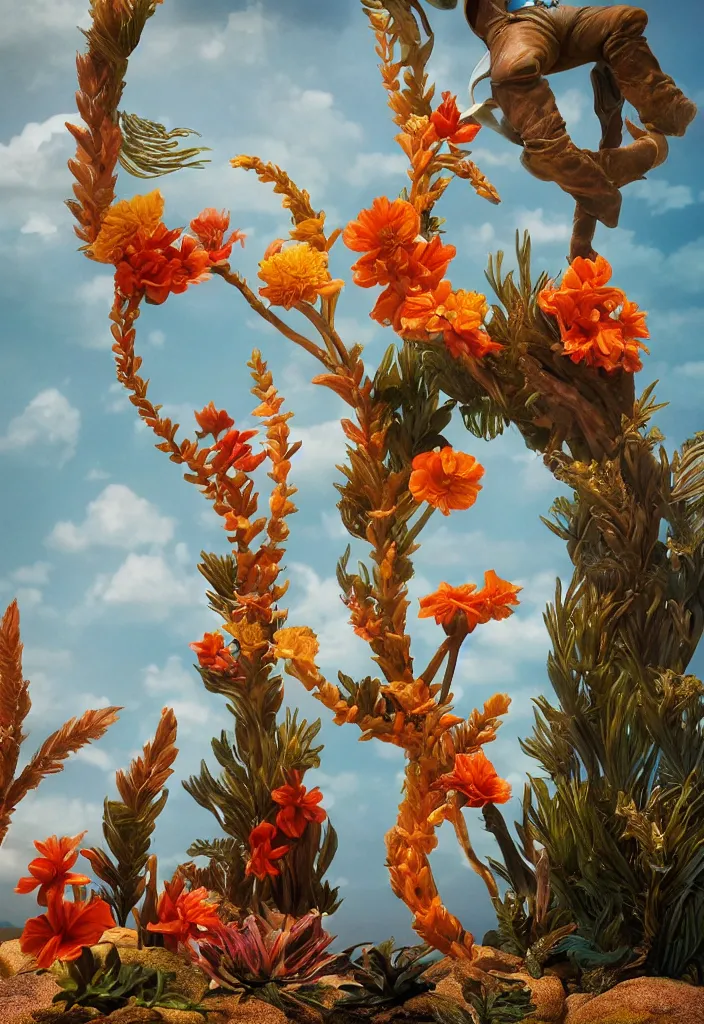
[604,33,697,136]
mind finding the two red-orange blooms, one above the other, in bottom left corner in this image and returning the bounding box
[14,831,115,970]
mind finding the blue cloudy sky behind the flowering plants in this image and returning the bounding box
[0,0,704,947]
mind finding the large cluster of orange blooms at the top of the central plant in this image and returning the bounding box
[343,197,501,358]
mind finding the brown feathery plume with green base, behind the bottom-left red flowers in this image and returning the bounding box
[82,708,178,931]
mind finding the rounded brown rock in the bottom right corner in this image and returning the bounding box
[564,978,704,1024]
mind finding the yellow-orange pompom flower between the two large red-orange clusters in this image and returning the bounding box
[259,242,345,309]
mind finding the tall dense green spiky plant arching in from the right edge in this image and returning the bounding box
[421,237,704,984]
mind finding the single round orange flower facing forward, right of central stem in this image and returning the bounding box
[408,446,484,515]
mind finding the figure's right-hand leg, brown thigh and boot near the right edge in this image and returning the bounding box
[561,4,697,135]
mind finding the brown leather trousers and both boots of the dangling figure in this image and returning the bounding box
[486,5,691,227]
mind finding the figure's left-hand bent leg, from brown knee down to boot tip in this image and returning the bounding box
[488,17,621,227]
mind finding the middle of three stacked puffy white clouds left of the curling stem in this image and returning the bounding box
[46,483,175,552]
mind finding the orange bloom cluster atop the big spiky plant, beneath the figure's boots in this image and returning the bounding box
[538,256,650,374]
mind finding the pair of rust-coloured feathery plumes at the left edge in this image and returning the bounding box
[0,601,122,844]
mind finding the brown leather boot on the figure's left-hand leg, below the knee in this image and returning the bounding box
[492,78,621,227]
